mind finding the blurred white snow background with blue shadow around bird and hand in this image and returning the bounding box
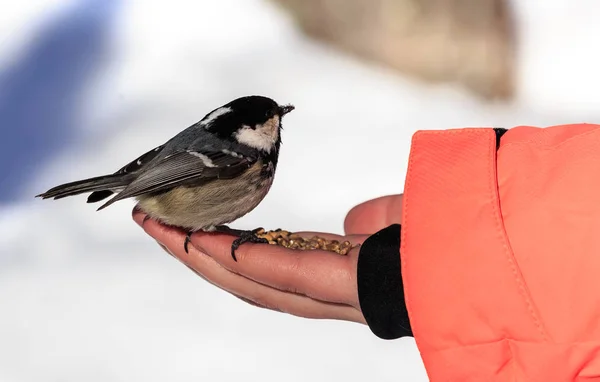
[0,0,600,382]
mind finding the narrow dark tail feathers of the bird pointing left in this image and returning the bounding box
[36,174,130,203]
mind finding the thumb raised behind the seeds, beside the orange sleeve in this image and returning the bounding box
[344,194,403,235]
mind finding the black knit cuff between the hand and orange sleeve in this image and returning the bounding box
[357,224,413,340]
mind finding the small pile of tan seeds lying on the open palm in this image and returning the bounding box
[254,228,359,255]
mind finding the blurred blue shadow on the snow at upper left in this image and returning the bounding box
[0,0,120,204]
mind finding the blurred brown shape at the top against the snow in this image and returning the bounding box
[272,0,515,99]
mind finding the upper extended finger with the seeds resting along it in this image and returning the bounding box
[191,232,358,307]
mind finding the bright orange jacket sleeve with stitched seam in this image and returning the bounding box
[400,124,600,382]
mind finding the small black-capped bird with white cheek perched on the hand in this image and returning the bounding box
[36,95,294,261]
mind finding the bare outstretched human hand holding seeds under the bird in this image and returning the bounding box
[133,195,402,324]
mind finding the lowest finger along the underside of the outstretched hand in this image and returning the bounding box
[134,215,364,323]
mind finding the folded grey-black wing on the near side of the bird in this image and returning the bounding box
[98,149,256,210]
